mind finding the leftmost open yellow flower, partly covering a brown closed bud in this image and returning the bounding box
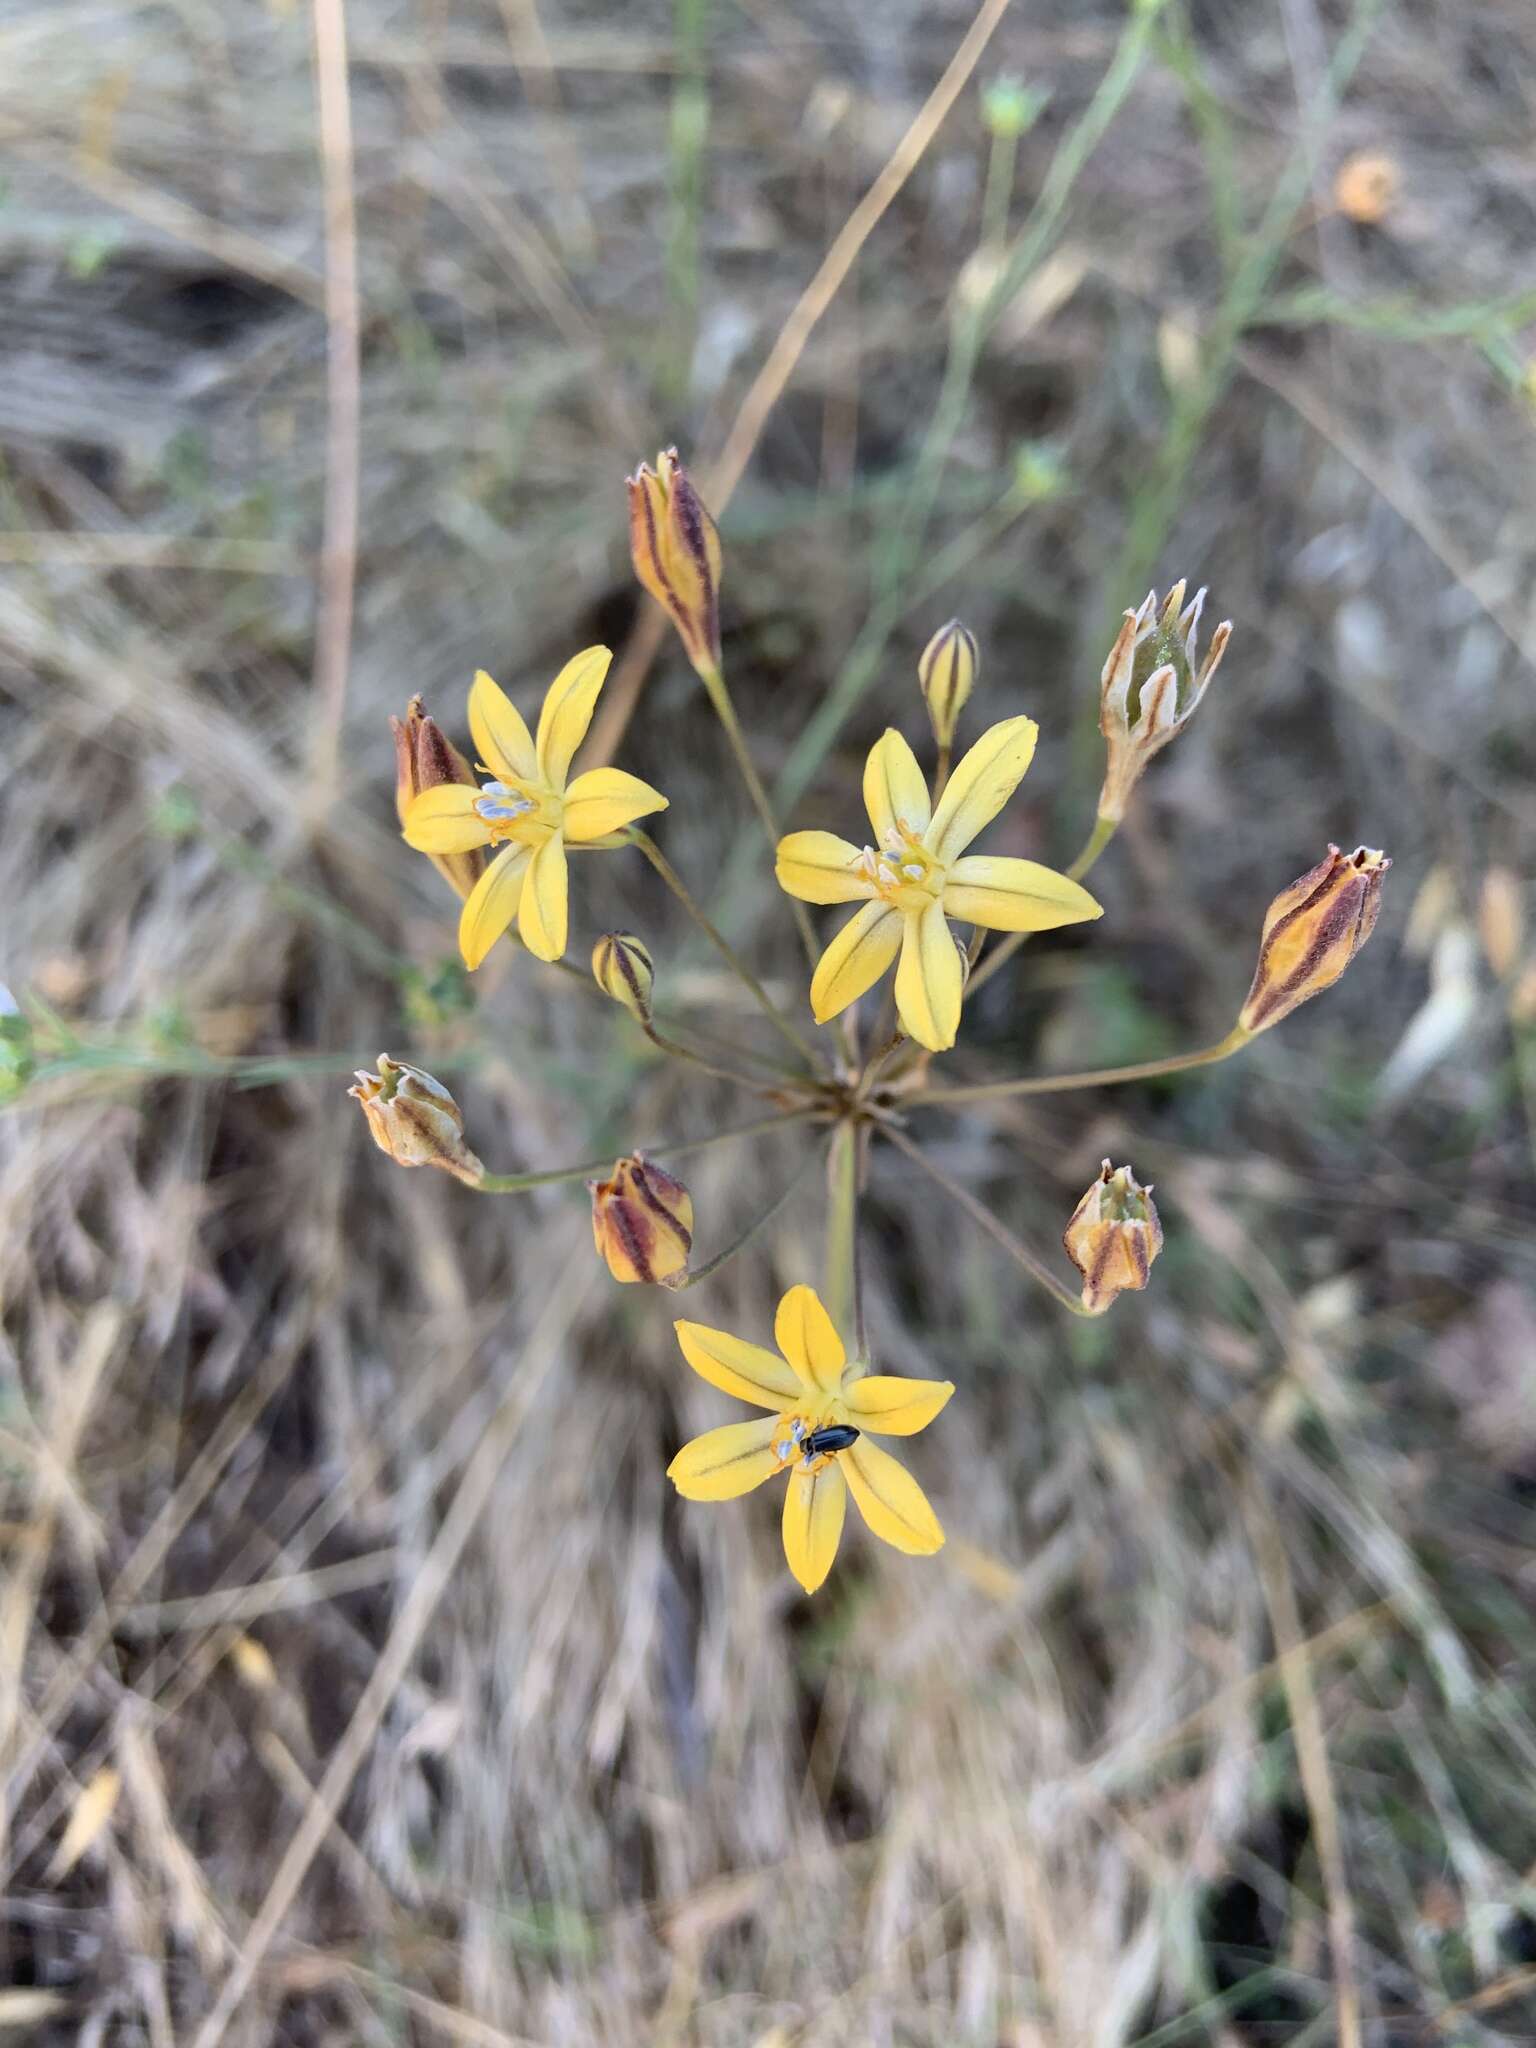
[403,647,668,969]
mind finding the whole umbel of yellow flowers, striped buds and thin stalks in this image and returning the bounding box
[352,449,1391,1593]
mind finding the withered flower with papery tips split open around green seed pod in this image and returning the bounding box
[1098,580,1233,823]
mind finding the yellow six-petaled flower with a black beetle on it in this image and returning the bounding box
[668,1277,954,1593]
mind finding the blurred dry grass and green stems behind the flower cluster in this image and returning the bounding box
[0,0,1536,2048]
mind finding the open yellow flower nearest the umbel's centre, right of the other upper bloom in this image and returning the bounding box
[778,719,1102,1053]
